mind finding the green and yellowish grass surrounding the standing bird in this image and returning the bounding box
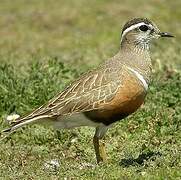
[0,0,181,179]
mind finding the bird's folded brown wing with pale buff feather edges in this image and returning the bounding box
[14,68,121,124]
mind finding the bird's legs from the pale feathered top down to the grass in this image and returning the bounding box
[93,127,107,163]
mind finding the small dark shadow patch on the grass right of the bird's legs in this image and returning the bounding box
[119,151,161,167]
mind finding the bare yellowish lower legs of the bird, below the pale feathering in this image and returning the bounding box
[93,136,107,163]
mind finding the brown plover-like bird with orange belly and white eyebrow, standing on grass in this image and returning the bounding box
[0,17,174,163]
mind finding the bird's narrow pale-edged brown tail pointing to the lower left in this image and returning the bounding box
[0,115,50,141]
